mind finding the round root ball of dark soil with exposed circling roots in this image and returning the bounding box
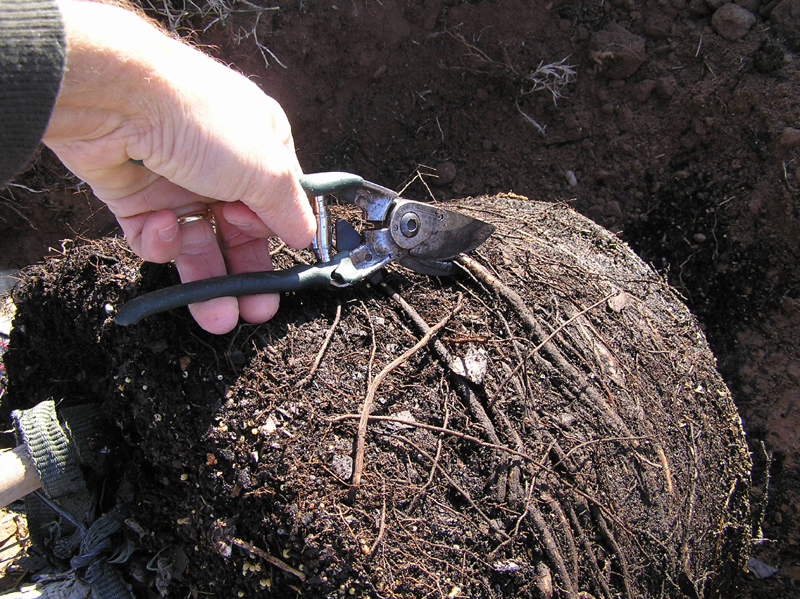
[5,197,758,598]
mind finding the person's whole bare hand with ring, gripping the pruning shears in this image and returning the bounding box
[44,0,316,333]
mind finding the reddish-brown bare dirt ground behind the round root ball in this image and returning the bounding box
[2,0,800,597]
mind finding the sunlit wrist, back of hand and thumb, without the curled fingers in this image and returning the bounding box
[45,2,315,254]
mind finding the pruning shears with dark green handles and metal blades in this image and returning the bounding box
[114,173,494,326]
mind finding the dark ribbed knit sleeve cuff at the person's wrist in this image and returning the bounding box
[0,0,66,186]
